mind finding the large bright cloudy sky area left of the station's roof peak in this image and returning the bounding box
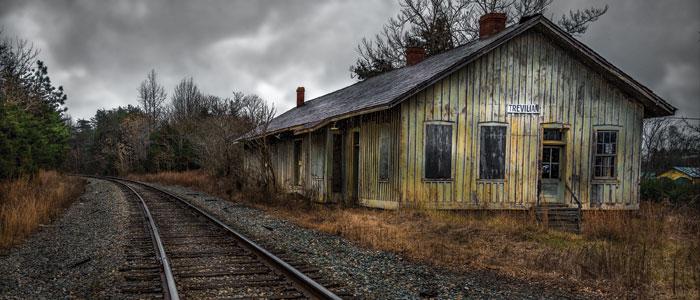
[0,1,395,118]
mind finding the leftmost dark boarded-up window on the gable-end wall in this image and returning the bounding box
[425,124,452,179]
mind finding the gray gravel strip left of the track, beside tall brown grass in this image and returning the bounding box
[0,179,129,299]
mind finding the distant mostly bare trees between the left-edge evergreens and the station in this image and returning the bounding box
[66,70,274,183]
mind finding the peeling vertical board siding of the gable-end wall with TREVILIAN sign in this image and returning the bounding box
[396,31,643,208]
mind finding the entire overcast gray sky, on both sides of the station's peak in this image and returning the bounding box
[0,0,700,118]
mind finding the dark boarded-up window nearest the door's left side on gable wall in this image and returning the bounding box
[479,125,506,179]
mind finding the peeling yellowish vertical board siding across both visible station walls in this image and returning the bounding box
[272,31,644,209]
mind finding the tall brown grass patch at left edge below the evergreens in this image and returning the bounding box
[0,171,84,249]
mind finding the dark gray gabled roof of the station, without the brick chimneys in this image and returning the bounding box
[254,15,675,138]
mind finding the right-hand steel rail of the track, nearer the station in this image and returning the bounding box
[105,177,341,299]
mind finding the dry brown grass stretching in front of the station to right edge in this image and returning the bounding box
[135,171,700,299]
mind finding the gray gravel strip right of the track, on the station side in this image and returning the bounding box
[146,185,587,299]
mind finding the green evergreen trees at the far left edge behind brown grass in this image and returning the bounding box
[0,31,70,180]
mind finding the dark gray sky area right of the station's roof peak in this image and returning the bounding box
[554,0,700,117]
